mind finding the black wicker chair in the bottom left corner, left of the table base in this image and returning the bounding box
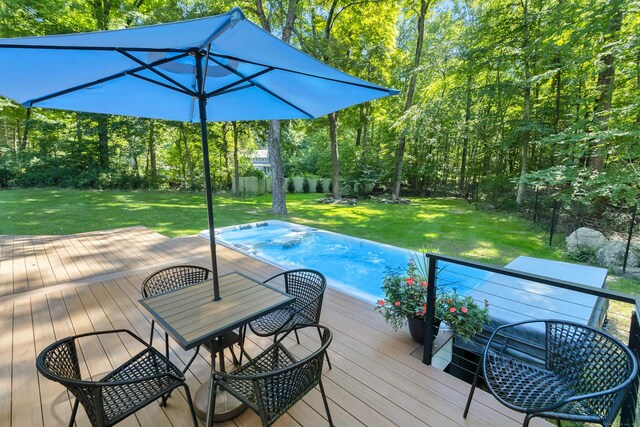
[36,329,198,427]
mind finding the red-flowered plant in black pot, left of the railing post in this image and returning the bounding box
[375,255,445,343]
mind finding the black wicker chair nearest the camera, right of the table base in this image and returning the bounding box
[211,325,333,426]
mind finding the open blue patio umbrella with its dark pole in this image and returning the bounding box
[0,8,397,299]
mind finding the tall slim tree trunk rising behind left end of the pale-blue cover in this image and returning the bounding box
[516,0,531,206]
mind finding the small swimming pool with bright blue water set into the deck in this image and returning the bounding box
[200,220,491,303]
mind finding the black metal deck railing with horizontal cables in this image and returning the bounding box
[422,253,640,426]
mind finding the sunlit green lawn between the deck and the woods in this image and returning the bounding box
[0,189,563,265]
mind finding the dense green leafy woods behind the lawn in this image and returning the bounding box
[0,0,640,219]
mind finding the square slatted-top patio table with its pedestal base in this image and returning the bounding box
[139,272,295,426]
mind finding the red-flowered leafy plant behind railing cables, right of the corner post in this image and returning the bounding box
[439,289,489,341]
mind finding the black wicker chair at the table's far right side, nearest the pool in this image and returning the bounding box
[245,269,331,369]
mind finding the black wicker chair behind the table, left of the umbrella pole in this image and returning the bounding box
[141,265,240,374]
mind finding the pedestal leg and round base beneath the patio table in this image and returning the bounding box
[200,343,247,427]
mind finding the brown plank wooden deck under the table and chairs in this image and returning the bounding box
[0,227,545,427]
